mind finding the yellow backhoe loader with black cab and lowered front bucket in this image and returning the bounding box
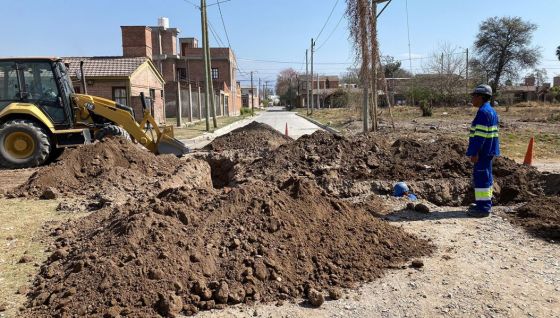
[0,58,189,169]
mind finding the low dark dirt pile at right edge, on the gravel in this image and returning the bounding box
[507,196,560,242]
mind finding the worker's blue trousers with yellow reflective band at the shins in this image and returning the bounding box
[473,156,494,212]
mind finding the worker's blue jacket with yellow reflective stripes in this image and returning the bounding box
[467,102,500,157]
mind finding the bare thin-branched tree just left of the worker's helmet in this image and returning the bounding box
[424,42,467,102]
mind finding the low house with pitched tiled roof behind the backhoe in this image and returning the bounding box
[63,56,165,123]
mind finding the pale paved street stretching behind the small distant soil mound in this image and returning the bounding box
[181,107,322,149]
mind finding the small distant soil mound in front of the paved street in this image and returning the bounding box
[204,121,293,153]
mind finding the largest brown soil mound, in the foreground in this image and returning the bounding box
[24,178,432,317]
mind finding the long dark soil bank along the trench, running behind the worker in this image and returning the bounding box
[236,131,543,205]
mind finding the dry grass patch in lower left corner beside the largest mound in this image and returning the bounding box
[0,199,85,317]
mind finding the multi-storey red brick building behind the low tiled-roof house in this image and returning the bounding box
[121,18,241,117]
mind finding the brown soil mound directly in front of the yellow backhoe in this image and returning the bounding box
[9,139,212,207]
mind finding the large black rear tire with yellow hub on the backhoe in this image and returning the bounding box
[0,119,53,169]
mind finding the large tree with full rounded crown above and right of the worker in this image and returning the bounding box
[474,17,541,92]
